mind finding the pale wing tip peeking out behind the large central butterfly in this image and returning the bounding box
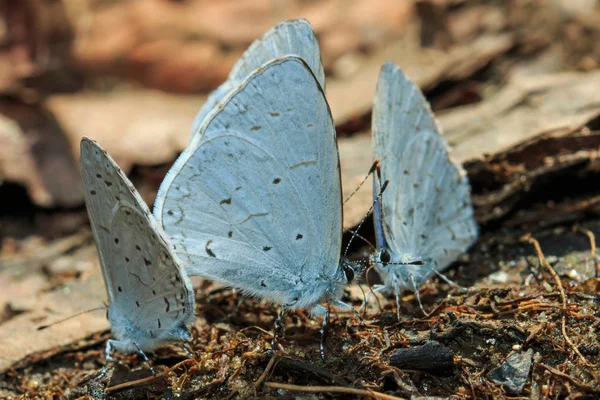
[192,19,325,137]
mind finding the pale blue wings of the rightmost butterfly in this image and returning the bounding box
[373,62,477,270]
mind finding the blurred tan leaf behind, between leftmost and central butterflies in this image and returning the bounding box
[47,90,205,173]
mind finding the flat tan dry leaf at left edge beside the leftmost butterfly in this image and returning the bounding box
[0,236,109,373]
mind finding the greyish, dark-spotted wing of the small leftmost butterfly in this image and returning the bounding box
[81,138,194,349]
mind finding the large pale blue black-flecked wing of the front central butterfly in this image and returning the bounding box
[154,56,342,303]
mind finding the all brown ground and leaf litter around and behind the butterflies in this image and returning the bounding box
[0,0,600,399]
